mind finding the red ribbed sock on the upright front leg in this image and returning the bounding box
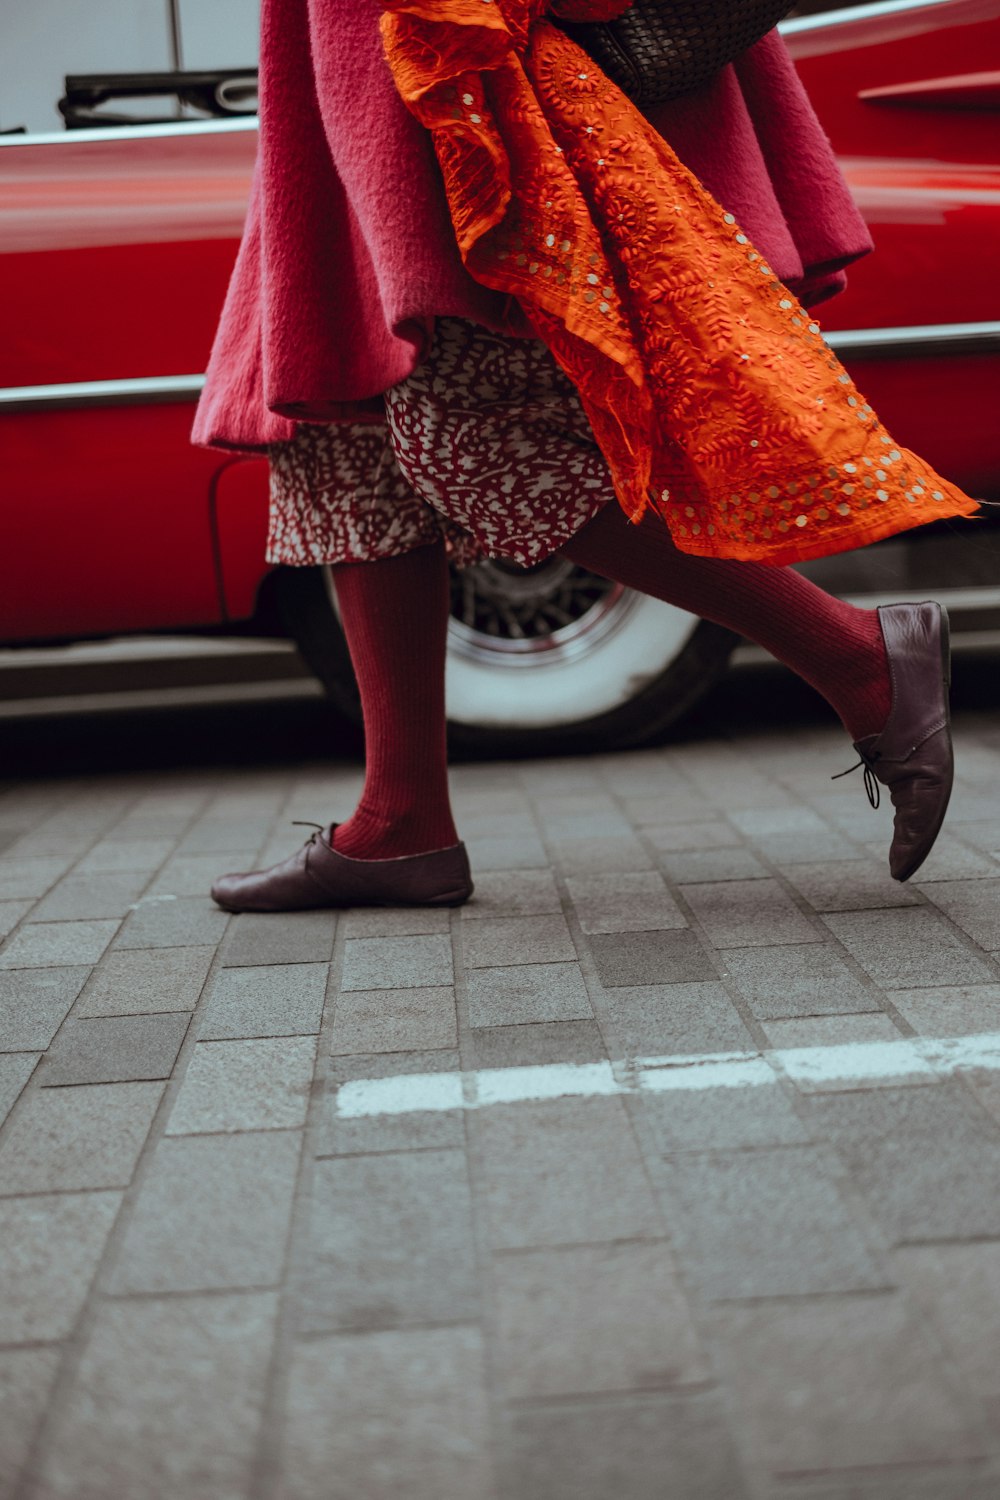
[333,543,459,860]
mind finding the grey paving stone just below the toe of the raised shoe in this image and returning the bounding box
[823,906,996,990]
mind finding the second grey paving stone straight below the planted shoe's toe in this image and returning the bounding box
[201,963,328,1041]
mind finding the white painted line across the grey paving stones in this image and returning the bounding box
[337,1032,1000,1119]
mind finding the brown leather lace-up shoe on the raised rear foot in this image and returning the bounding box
[855,600,955,881]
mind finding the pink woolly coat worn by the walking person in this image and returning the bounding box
[193,0,871,450]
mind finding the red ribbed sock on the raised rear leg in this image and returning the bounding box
[562,504,892,740]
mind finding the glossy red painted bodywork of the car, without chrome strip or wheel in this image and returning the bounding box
[0,0,1000,642]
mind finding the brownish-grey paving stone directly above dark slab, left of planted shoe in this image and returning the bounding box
[73,947,214,1019]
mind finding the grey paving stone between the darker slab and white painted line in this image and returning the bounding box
[598,984,756,1058]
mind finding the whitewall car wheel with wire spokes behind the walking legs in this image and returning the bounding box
[274,557,738,756]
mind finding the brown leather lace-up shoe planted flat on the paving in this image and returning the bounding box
[211,824,472,912]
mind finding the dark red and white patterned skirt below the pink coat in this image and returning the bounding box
[267,318,615,566]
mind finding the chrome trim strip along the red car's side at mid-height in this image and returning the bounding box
[0,321,1000,413]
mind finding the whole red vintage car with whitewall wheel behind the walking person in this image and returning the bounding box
[0,0,1000,752]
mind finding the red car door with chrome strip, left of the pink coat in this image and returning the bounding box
[0,120,262,642]
